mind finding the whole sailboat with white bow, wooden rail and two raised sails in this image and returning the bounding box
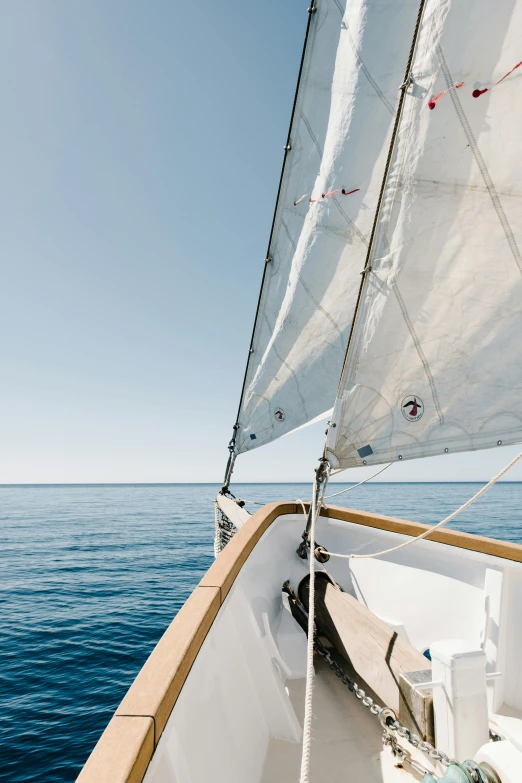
[78,0,522,783]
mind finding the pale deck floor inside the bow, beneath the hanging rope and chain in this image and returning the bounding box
[261,657,430,783]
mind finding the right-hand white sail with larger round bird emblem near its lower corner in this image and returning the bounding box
[327,0,522,468]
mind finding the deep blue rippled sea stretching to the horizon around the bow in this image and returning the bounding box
[0,482,522,783]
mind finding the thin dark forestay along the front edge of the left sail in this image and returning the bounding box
[221,0,317,493]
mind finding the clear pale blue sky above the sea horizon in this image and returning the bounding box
[0,0,522,483]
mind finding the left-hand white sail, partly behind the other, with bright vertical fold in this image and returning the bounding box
[235,0,418,453]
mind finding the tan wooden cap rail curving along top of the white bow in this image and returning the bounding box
[77,502,522,783]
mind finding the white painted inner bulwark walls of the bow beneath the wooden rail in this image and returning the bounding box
[140,515,522,783]
